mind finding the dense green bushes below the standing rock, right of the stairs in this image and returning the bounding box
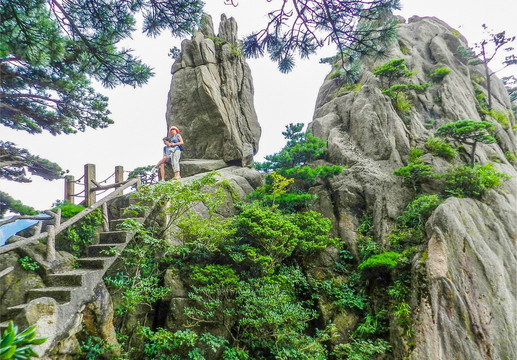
[98,174,339,359]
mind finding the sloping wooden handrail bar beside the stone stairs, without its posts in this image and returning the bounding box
[0,177,140,254]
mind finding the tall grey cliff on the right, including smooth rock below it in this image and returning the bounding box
[310,17,517,359]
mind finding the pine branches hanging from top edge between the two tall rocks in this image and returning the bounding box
[240,0,399,72]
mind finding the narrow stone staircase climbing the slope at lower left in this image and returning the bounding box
[0,199,150,333]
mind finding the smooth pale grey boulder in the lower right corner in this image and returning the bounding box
[410,179,517,360]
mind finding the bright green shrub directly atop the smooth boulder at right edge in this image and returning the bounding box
[439,164,510,199]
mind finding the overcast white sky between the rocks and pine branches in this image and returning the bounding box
[0,0,517,209]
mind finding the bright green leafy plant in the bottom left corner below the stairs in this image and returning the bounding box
[0,320,47,360]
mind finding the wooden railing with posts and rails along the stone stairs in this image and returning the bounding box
[0,164,140,261]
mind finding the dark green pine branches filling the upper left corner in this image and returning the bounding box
[0,0,203,214]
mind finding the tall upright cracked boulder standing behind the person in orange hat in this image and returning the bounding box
[167,15,261,165]
